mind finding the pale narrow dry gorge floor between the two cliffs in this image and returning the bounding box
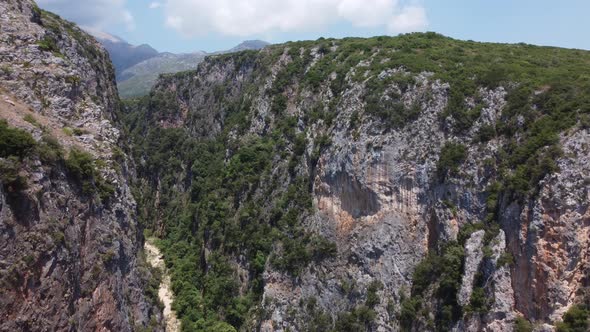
[144,239,180,332]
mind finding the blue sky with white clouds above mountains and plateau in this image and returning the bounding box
[37,0,590,53]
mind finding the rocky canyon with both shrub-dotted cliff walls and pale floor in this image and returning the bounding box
[0,0,590,331]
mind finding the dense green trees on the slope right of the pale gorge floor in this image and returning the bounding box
[123,80,336,331]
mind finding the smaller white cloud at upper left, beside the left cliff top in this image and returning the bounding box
[37,0,135,30]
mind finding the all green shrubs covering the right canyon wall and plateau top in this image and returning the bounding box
[122,33,590,331]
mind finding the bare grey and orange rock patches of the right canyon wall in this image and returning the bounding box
[140,44,590,331]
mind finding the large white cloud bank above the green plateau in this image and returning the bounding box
[163,0,428,36]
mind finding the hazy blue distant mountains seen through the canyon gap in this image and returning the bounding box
[87,29,270,98]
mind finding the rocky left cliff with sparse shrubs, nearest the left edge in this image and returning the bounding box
[0,0,161,331]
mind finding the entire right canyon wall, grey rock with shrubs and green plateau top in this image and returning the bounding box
[128,35,590,331]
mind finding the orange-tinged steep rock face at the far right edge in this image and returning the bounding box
[505,129,590,320]
